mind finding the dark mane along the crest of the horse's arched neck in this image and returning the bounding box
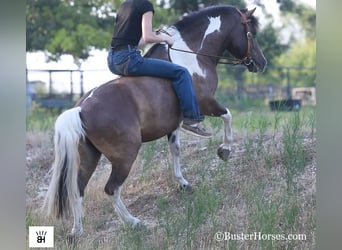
[173,5,259,33]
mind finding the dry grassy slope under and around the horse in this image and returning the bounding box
[26,108,316,250]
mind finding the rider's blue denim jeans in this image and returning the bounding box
[107,47,204,121]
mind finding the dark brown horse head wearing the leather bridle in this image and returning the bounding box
[227,8,267,72]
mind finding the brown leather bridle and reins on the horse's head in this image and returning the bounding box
[162,8,253,66]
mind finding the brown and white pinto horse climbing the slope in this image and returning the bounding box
[44,5,267,238]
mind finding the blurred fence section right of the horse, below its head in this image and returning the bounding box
[217,65,316,107]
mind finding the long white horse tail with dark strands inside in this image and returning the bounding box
[43,107,85,218]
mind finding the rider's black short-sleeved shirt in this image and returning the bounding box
[111,0,154,47]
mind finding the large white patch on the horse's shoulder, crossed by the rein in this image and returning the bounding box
[167,27,206,78]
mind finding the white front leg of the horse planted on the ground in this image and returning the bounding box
[168,128,192,192]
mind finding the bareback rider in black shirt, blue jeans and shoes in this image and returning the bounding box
[107,0,211,138]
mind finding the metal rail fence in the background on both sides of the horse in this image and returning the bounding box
[27,65,316,108]
